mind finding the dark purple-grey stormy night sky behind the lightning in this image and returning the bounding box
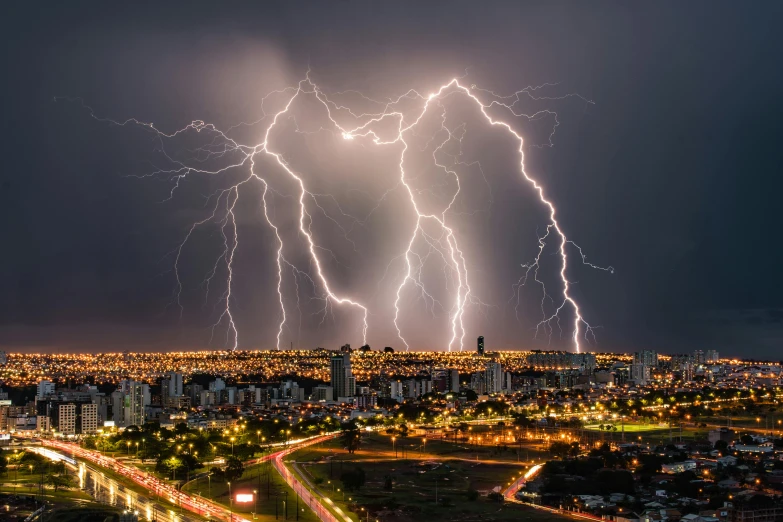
[0,1,783,359]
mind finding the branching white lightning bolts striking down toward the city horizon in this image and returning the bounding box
[62,70,614,352]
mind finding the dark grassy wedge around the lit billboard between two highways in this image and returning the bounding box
[183,463,318,522]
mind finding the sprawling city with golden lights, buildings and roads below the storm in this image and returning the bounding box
[0,342,783,522]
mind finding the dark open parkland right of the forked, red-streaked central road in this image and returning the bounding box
[288,426,562,522]
